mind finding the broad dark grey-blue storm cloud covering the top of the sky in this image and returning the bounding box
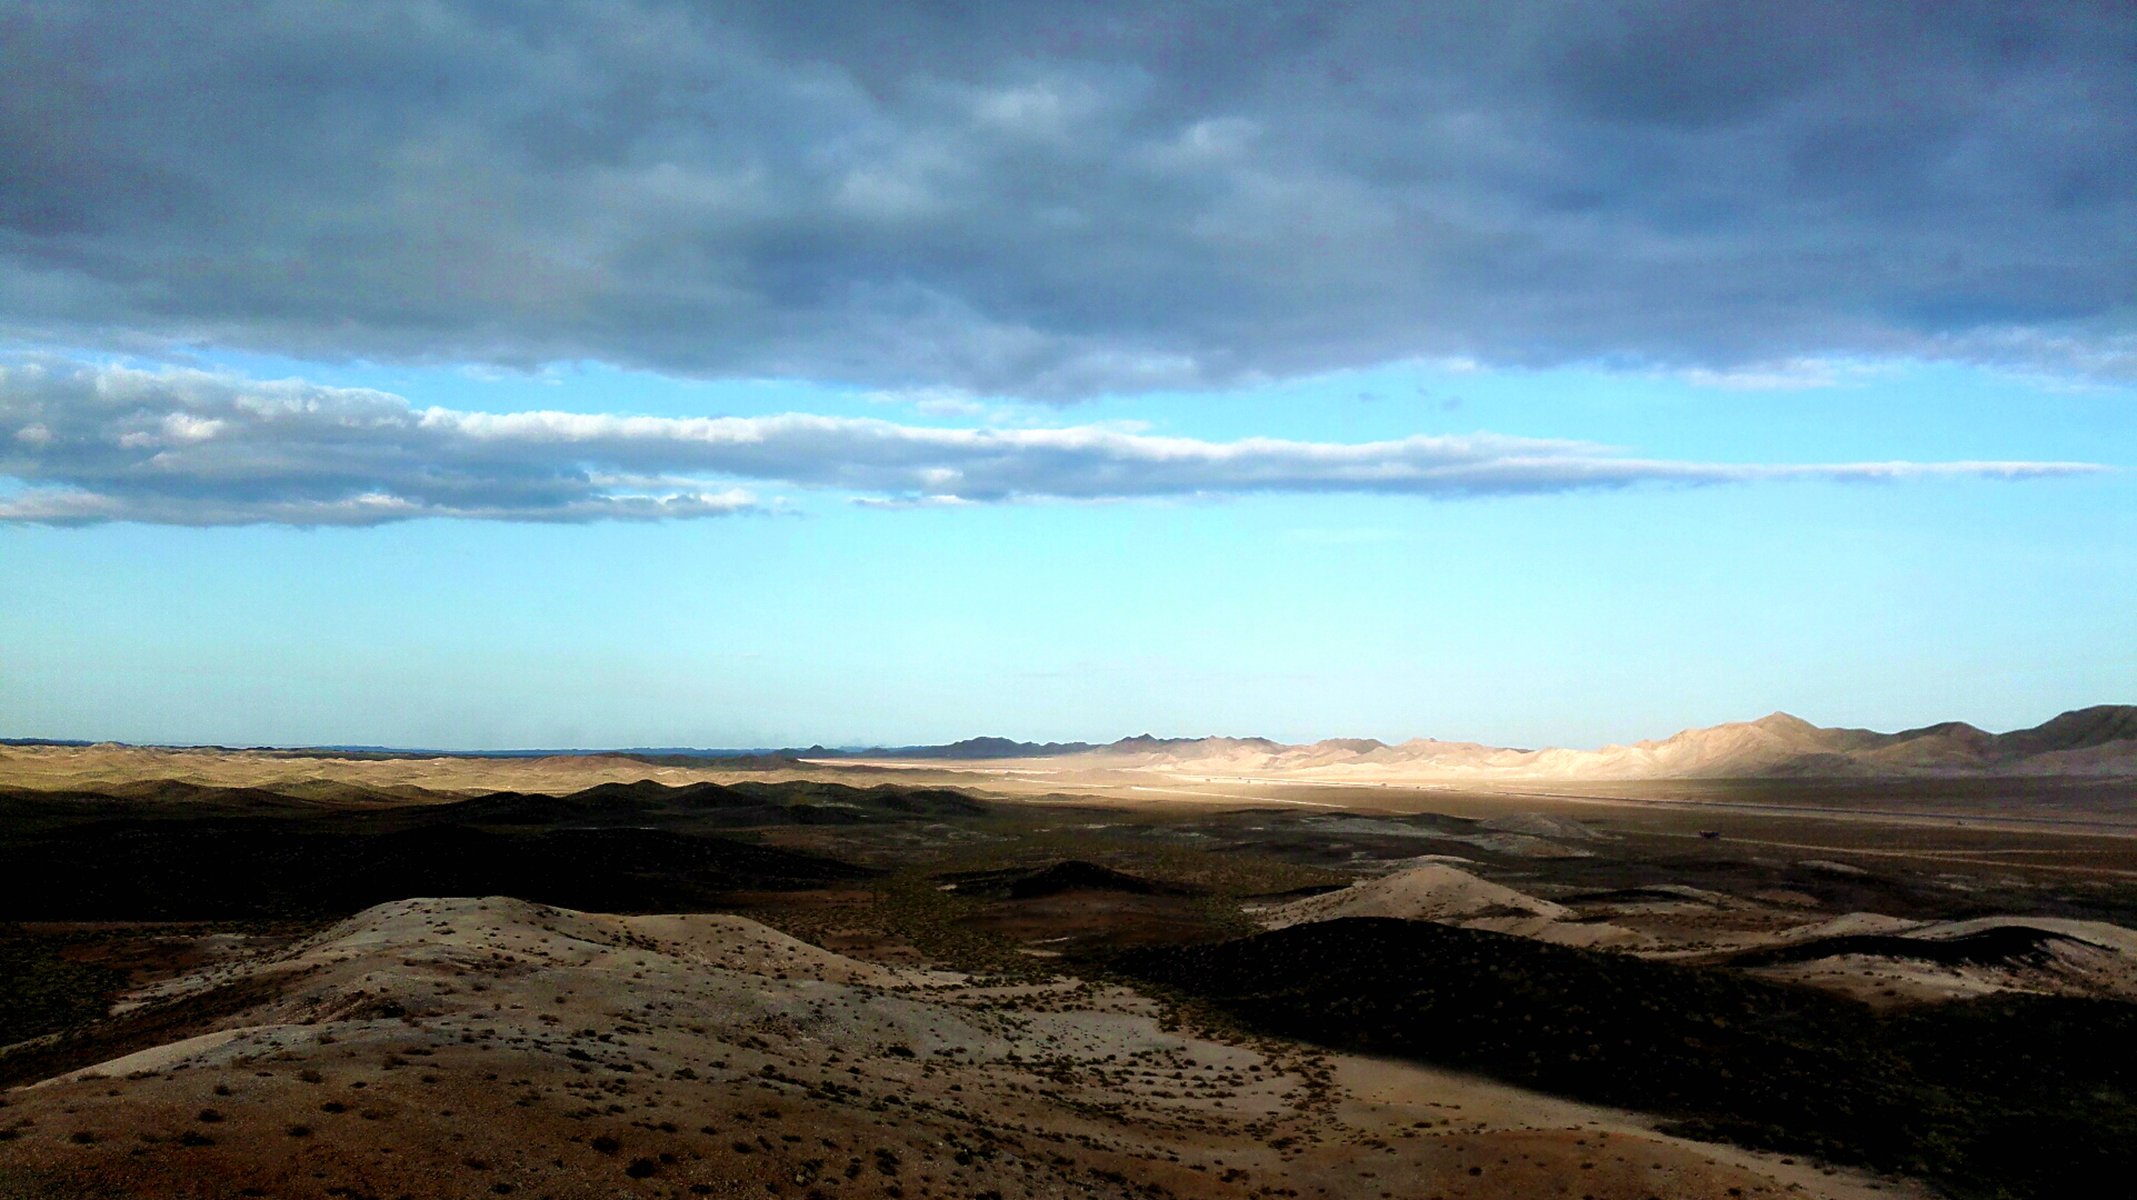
[0,0,2137,399]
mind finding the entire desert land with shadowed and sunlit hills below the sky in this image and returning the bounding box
[0,709,2137,1200]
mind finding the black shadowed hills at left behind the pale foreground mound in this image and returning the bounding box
[0,781,961,920]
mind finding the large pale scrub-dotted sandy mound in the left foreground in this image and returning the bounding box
[0,897,1908,1200]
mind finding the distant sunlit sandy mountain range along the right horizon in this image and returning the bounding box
[833,705,2137,784]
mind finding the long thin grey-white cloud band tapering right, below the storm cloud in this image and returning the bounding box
[0,359,2103,525]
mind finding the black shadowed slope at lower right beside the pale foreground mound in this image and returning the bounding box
[1111,918,2137,1200]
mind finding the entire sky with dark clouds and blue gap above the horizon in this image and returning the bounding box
[0,0,2137,749]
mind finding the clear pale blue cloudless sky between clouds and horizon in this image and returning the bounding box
[0,352,2137,747]
